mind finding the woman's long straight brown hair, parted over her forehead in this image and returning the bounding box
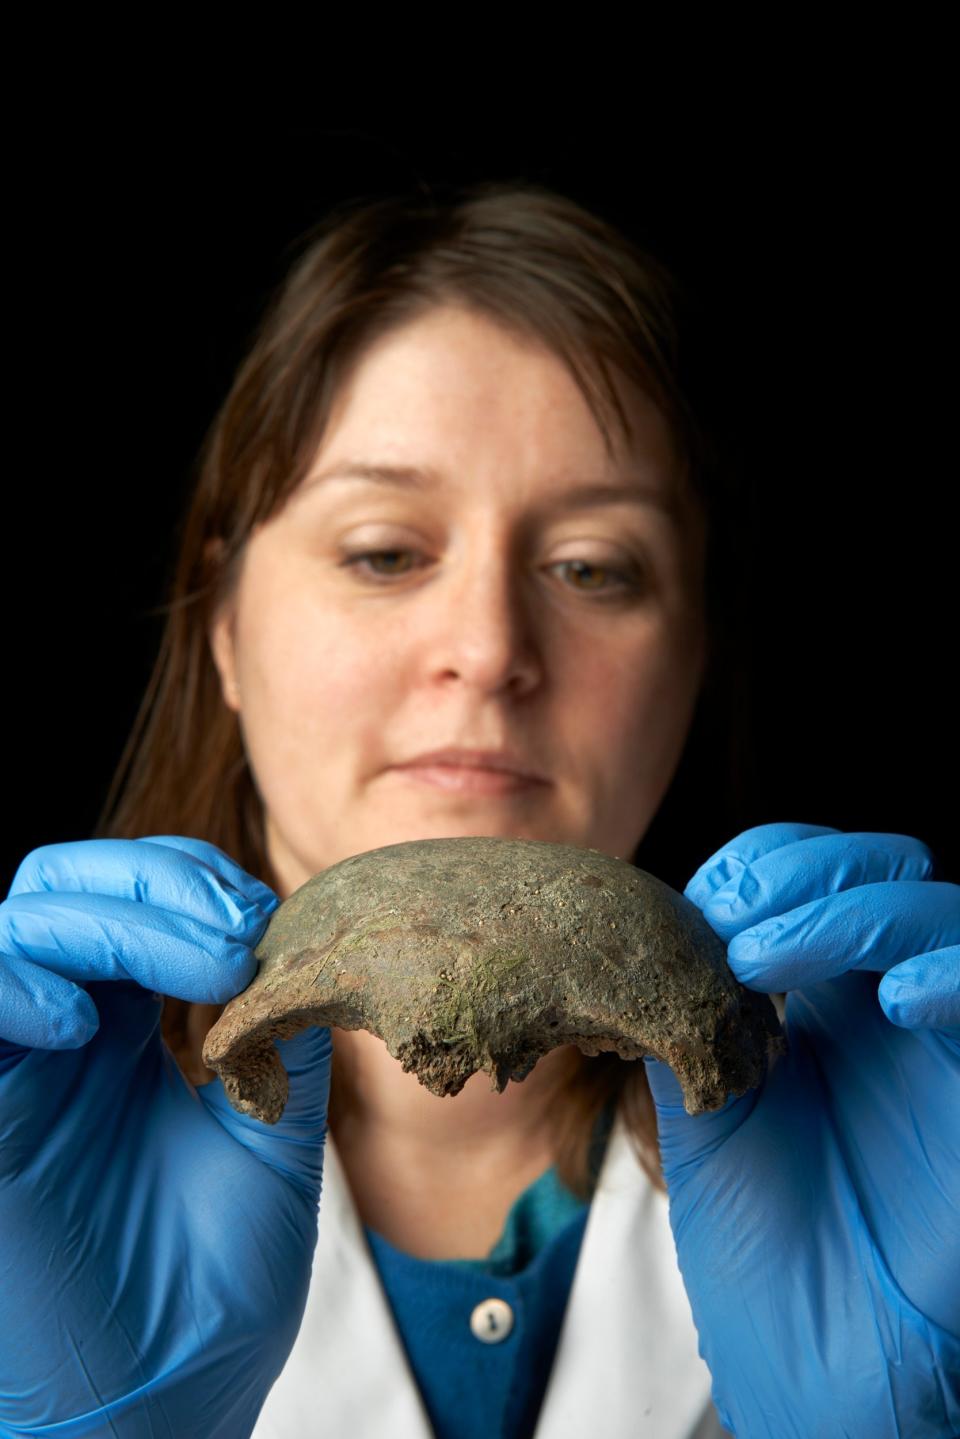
[95,181,742,1196]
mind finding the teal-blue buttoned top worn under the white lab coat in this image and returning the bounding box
[359,1109,612,1439]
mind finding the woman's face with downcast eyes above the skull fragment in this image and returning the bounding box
[210,307,705,896]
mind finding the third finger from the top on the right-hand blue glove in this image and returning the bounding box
[727,879,960,993]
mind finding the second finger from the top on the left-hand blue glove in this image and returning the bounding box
[7,837,279,943]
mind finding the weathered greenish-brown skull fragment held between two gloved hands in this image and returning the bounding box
[203,836,783,1124]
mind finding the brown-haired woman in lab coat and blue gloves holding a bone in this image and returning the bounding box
[0,186,960,1439]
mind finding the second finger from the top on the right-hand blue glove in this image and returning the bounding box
[704,830,936,948]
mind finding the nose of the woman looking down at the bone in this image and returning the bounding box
[426,535,543,696]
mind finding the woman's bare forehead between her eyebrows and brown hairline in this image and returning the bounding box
[321,305,678,482]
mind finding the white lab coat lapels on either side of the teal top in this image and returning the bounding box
[253,1114,727,1439]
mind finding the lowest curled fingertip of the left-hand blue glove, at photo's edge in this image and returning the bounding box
[0,954,99,1049]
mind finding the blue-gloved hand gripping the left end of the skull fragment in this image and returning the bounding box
[0,836,331,1439]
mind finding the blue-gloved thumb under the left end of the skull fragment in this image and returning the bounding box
[197,1025,332,1194]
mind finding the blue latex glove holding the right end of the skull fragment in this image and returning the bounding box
[646,825,960,1439]
